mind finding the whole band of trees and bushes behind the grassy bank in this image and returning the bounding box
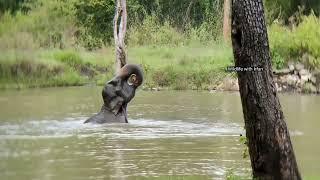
[0,0,320,68]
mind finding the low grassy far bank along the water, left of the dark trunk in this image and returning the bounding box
[0,45,232,90]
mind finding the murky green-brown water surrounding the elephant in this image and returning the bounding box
[0,87,320,180]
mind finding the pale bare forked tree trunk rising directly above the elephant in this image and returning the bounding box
[113,0,127,73]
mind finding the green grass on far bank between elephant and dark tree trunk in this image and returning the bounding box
[129,45,233,90]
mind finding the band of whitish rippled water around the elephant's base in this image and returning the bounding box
[0,117,248,139]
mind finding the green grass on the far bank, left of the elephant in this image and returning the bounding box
[0,50,113,89]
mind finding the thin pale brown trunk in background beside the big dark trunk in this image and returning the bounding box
[223,0,231,42]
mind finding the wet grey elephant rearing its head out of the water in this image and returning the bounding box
[84,64,143,124]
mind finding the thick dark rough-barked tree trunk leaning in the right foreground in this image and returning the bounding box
[231,0,301,180]
